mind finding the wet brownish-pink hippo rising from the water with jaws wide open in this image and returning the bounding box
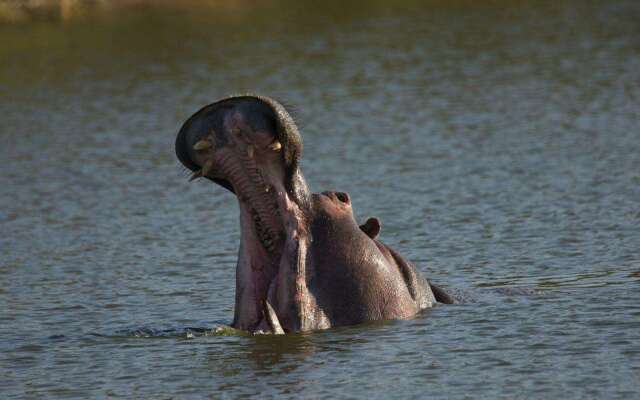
[175,95,453,334]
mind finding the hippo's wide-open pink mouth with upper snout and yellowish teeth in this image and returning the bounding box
[176,96,306,330]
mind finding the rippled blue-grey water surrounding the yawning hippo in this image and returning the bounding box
[0,0,640,399]
